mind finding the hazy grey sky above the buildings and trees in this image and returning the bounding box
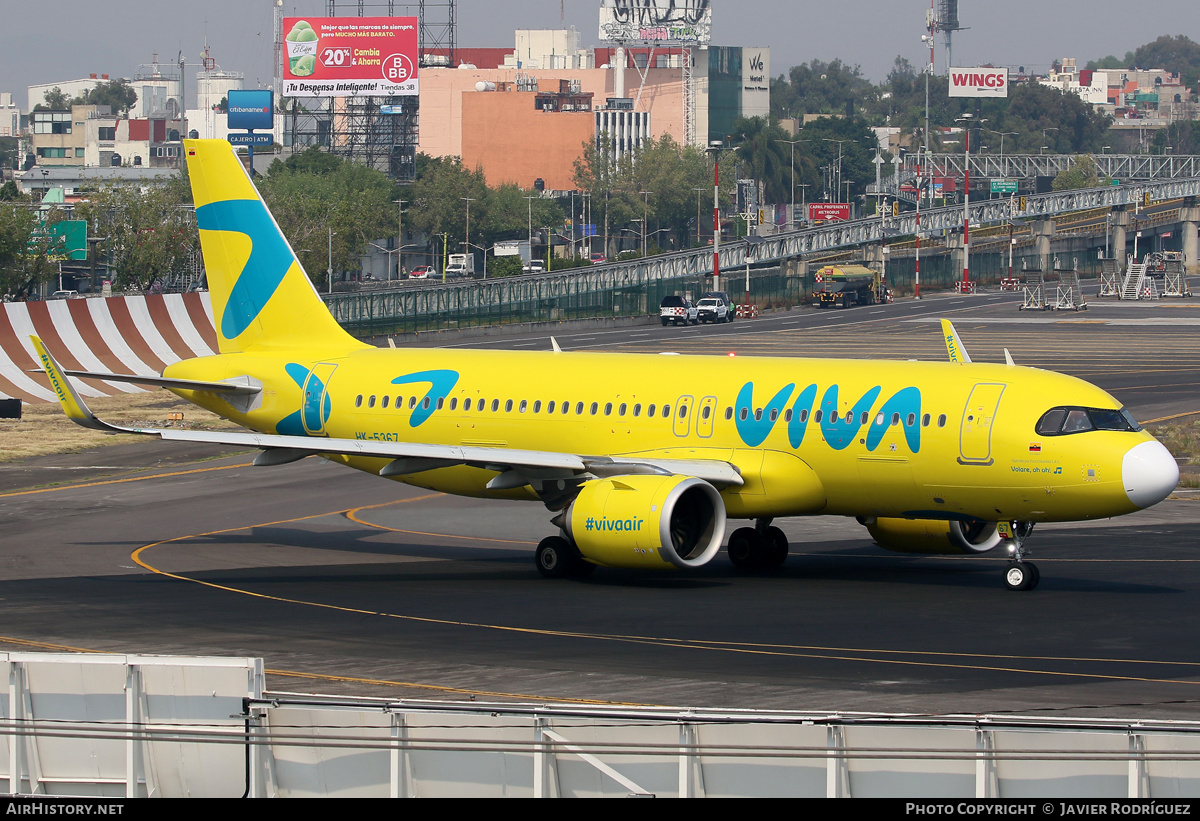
[0,0,1200,107]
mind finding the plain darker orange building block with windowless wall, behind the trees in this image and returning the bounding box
[462,80,595,191]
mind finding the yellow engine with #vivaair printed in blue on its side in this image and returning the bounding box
[563,475,725,570]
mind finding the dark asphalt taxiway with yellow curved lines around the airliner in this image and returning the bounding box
[0,294,1200,719]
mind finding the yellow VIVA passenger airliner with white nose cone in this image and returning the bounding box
[34,140,1178,589]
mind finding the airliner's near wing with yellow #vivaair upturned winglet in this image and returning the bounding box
[30,336,743,490]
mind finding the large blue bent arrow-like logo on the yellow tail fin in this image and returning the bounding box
[196,199,293,340]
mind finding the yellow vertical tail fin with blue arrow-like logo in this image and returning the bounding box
[184,139,364,353]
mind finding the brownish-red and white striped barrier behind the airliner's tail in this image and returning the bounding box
[0,293,217,402]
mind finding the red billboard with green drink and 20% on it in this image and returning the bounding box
[283,17,418,97]
